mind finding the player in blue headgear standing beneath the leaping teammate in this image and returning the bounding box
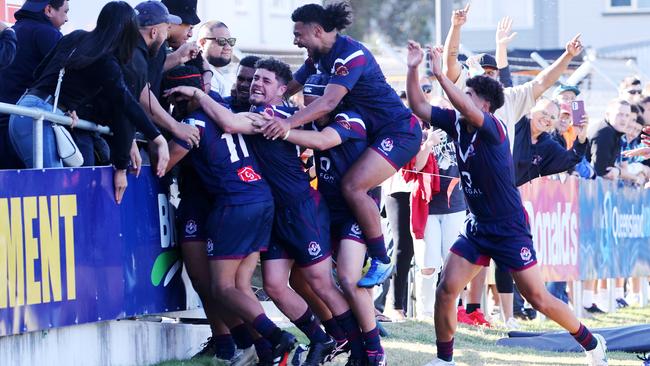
[287,74,386,365]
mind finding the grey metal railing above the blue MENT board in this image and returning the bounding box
[0,103,111,169]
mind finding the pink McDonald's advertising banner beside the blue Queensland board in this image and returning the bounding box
[519,177,582,281]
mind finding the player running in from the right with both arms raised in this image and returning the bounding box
[407,41,607,365]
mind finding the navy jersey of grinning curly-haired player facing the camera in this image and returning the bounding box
[250,105,311,205]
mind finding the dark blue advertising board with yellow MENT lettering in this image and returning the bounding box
[0,167,185,336]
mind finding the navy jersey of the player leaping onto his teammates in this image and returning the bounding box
[294,35,411,137]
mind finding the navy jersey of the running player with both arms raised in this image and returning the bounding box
[431,107,524,222]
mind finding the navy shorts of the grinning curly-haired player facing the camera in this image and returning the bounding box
[262,190,332,267]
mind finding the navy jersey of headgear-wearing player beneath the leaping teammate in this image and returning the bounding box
[312,111,368,222]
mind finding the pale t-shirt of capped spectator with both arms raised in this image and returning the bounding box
[454,68,535,152]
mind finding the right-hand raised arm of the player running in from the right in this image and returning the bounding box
[427,48,484,128]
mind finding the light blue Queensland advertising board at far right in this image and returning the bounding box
[578,179,650,279]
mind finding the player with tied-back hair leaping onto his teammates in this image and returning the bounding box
[262,2,422,287]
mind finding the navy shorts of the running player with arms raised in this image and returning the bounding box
[451,214,537,272]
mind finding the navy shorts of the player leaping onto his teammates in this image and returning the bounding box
[370,115,422,170]
